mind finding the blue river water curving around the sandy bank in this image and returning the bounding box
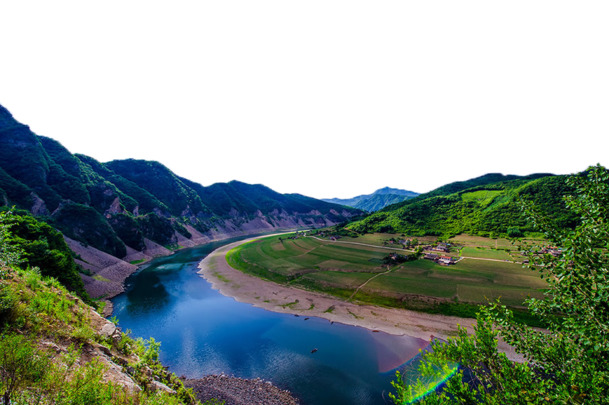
[113,237,426,405]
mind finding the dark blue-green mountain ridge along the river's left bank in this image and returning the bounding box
[0,102,363,296]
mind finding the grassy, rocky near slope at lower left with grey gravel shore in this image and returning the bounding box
[0,212,297,405]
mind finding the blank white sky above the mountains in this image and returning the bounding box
[0,0,609,198]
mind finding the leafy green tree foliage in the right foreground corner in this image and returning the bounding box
[394,165,609,404]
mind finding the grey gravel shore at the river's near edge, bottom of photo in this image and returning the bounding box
[184,375,299,405]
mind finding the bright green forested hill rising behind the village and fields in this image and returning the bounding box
[347,173,576,236]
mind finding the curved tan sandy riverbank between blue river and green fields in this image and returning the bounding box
[199,235,519,360]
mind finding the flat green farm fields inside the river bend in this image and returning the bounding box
[227,234,545,316]
